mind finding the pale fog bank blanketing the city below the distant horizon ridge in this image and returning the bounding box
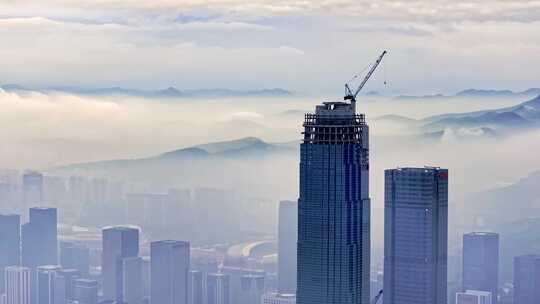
[0,87,540,278]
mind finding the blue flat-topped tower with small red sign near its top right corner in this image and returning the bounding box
[383,167,448,304]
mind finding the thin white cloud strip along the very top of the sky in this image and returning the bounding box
[4,0,540,22]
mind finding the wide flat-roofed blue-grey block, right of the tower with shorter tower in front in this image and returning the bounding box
[150,240,190,304]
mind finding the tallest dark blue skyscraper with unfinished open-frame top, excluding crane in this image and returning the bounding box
[297,102,371,304]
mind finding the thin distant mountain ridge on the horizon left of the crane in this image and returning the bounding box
[0,84,293,98]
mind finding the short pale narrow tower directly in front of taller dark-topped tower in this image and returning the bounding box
[122,257,143,304]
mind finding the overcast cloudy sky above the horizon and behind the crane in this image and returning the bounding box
[0,0,540,94]
